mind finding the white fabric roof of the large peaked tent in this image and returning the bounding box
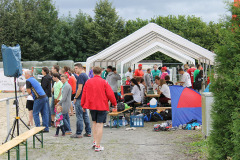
[86,23,215,72]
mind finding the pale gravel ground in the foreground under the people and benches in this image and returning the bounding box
[0,92,206,160]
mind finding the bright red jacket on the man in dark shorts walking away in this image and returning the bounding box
[81,75,117,111]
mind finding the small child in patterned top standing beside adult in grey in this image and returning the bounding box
[55,106,65,137]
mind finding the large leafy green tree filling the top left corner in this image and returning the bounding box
[0,0,59,60]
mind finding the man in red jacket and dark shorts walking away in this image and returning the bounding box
[81,67,117,152]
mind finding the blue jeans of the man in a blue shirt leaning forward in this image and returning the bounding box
[33,97,49,131]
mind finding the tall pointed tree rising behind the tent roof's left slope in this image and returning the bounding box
[88,0,124,55]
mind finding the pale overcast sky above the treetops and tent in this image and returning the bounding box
[54,0,231,22]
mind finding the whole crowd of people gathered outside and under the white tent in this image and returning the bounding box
[20,63,203,151]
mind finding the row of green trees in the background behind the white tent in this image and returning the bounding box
[0,0,224,62]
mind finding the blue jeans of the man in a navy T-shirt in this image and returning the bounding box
[75,99,91,135]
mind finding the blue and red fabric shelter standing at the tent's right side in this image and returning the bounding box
[170,86,202,127]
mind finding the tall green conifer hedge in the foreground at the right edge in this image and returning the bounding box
[209,1,240,160]
